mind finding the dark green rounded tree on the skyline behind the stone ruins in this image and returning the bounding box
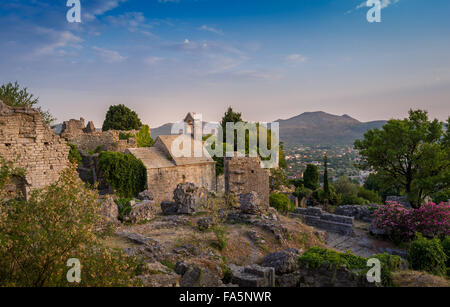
[102,104,142,131]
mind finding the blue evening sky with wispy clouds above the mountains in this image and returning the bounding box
[0,0,450,127]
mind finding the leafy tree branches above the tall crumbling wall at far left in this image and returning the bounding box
[0,81,56,125]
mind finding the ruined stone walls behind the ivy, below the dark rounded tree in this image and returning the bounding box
[61,118,138,156]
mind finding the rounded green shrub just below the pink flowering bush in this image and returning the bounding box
[407,234,447,276]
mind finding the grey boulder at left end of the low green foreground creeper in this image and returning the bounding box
[261,248,301,275]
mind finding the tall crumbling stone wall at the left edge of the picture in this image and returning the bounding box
[0,101,69,197]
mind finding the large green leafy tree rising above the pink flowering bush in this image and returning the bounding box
[355,110,450,208]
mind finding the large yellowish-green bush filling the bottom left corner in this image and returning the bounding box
[0,166,142,287]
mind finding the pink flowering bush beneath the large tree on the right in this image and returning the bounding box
[372,202,450,242]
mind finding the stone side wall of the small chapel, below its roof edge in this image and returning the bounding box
[147,163,216,203]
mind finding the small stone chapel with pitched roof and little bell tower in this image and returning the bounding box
[126,113,216,202]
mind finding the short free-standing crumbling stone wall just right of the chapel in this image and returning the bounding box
[225,156,270,207]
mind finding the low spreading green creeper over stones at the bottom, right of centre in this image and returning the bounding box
[299,247,401,287]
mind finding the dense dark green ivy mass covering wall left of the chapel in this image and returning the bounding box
[99,151,147,198]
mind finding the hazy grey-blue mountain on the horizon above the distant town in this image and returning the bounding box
[277,112,386,145]
